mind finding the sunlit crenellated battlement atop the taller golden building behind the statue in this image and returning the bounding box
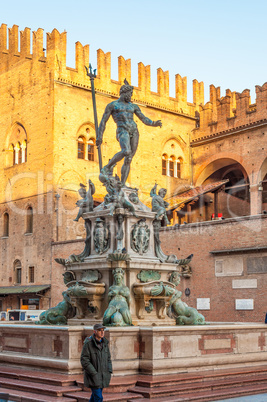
[0,24,207,119]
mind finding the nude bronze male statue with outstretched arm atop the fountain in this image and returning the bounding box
[96,80,162,184]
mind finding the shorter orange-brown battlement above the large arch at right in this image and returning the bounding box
[192,83,267,143]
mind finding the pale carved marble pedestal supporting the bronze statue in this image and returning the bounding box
[66,202,180,326]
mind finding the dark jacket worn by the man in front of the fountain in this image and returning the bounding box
[81,335,112,388]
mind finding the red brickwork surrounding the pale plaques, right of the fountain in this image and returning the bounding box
[161,215,267,322]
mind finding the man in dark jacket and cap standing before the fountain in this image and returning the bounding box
[81,324,112,402]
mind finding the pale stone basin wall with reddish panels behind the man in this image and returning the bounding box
[0,323,267,376]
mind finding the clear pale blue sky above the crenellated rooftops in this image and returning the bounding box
[0,0,267,102]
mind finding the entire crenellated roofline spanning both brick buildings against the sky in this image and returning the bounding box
[3,24,267,129]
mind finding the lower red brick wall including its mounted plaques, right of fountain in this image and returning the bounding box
[161,215,267,322]
